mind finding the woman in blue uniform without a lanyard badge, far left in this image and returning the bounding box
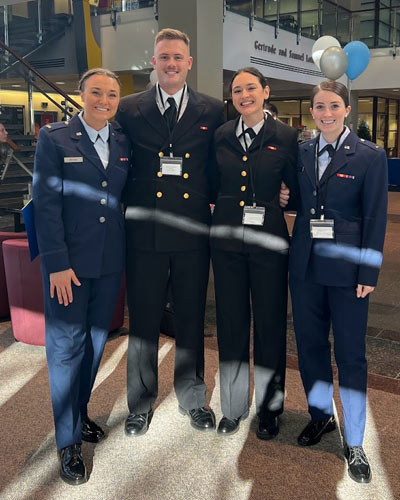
[33,68,130,484]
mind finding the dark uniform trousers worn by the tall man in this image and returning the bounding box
[127,246,209,413]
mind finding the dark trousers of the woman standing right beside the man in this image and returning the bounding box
[211,249,288,419]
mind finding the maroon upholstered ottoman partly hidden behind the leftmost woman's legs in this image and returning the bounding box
[3,239,125,345]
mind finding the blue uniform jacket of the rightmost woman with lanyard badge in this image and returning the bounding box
[289,132,387,287]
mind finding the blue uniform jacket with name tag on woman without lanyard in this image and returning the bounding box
[33,116,130,278]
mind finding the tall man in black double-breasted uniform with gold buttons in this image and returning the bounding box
[117,29,223,436]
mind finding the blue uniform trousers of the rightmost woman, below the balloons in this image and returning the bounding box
[289,276,369,446]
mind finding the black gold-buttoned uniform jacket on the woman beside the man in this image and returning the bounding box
[211,117,299,252]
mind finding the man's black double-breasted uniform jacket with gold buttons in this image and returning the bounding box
[117,87,223,252]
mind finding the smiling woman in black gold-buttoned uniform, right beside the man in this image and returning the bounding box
[211,68,297,439]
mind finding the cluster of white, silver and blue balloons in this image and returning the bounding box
[312,35,369,80]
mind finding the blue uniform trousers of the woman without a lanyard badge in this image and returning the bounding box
[43,272,122,450]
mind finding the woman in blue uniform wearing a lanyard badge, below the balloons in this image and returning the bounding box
[289,81,387,482]
